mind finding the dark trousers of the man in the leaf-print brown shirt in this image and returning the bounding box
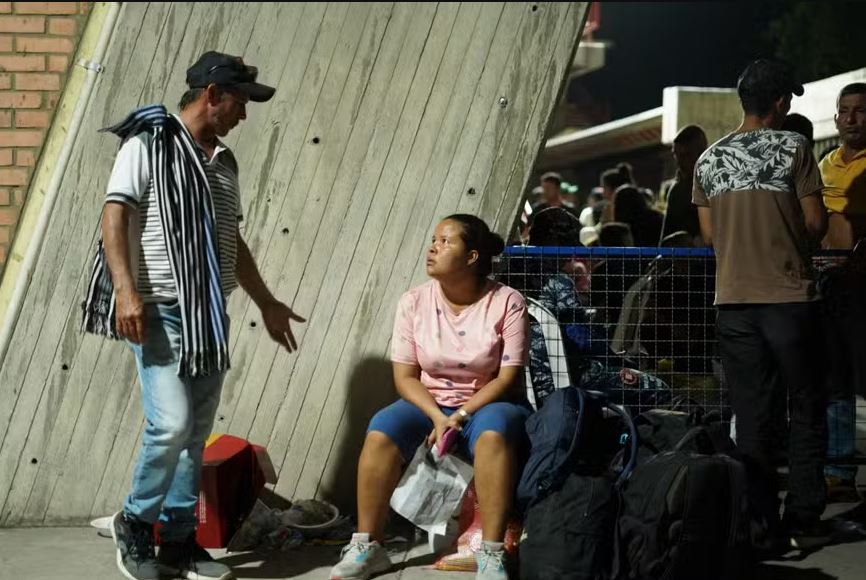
[717,303,827,529]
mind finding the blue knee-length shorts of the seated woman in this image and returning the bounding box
[367,399,532,463]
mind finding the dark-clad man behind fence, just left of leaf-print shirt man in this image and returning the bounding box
[659,125,707,245]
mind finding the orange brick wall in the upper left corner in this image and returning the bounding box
[0,2,92,272]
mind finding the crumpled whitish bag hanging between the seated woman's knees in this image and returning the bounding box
[391,444,473,547]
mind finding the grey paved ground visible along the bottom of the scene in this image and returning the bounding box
[0,496,866,580]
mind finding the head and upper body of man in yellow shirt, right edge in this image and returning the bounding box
[819,83,866,250]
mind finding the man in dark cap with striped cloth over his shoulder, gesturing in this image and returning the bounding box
[84,52,304,580]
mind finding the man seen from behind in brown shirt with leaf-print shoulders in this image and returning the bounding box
[693,60,827,549]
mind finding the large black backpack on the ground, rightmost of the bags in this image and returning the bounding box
[613,424,750,580]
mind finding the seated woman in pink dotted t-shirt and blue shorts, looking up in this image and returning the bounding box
[331,214,531,580]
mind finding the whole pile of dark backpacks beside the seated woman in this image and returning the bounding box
[517,387,752,580]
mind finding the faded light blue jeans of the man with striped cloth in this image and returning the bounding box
[124,302,225,541]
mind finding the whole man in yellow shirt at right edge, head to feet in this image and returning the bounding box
[820,83,866,502]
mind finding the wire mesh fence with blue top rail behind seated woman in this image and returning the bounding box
[495,246,866,462]
